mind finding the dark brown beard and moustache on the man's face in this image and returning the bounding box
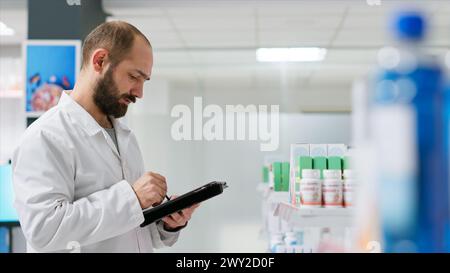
[94,67,136,118]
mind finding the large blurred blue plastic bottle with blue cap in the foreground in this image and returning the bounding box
[372,11,449,252]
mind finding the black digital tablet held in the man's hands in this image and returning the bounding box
[141,181,228,227]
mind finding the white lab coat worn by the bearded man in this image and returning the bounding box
[12,92,179,252]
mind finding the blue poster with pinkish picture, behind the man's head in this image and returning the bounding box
[25,42,79,112]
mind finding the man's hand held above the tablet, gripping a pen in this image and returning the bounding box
[132,172,167,209]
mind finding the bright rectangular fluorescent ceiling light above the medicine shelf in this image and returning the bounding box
[256,47,327,62]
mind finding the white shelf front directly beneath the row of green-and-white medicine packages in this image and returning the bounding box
[274,202,354,228]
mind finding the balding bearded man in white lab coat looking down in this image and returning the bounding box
[12,21,197,252]
